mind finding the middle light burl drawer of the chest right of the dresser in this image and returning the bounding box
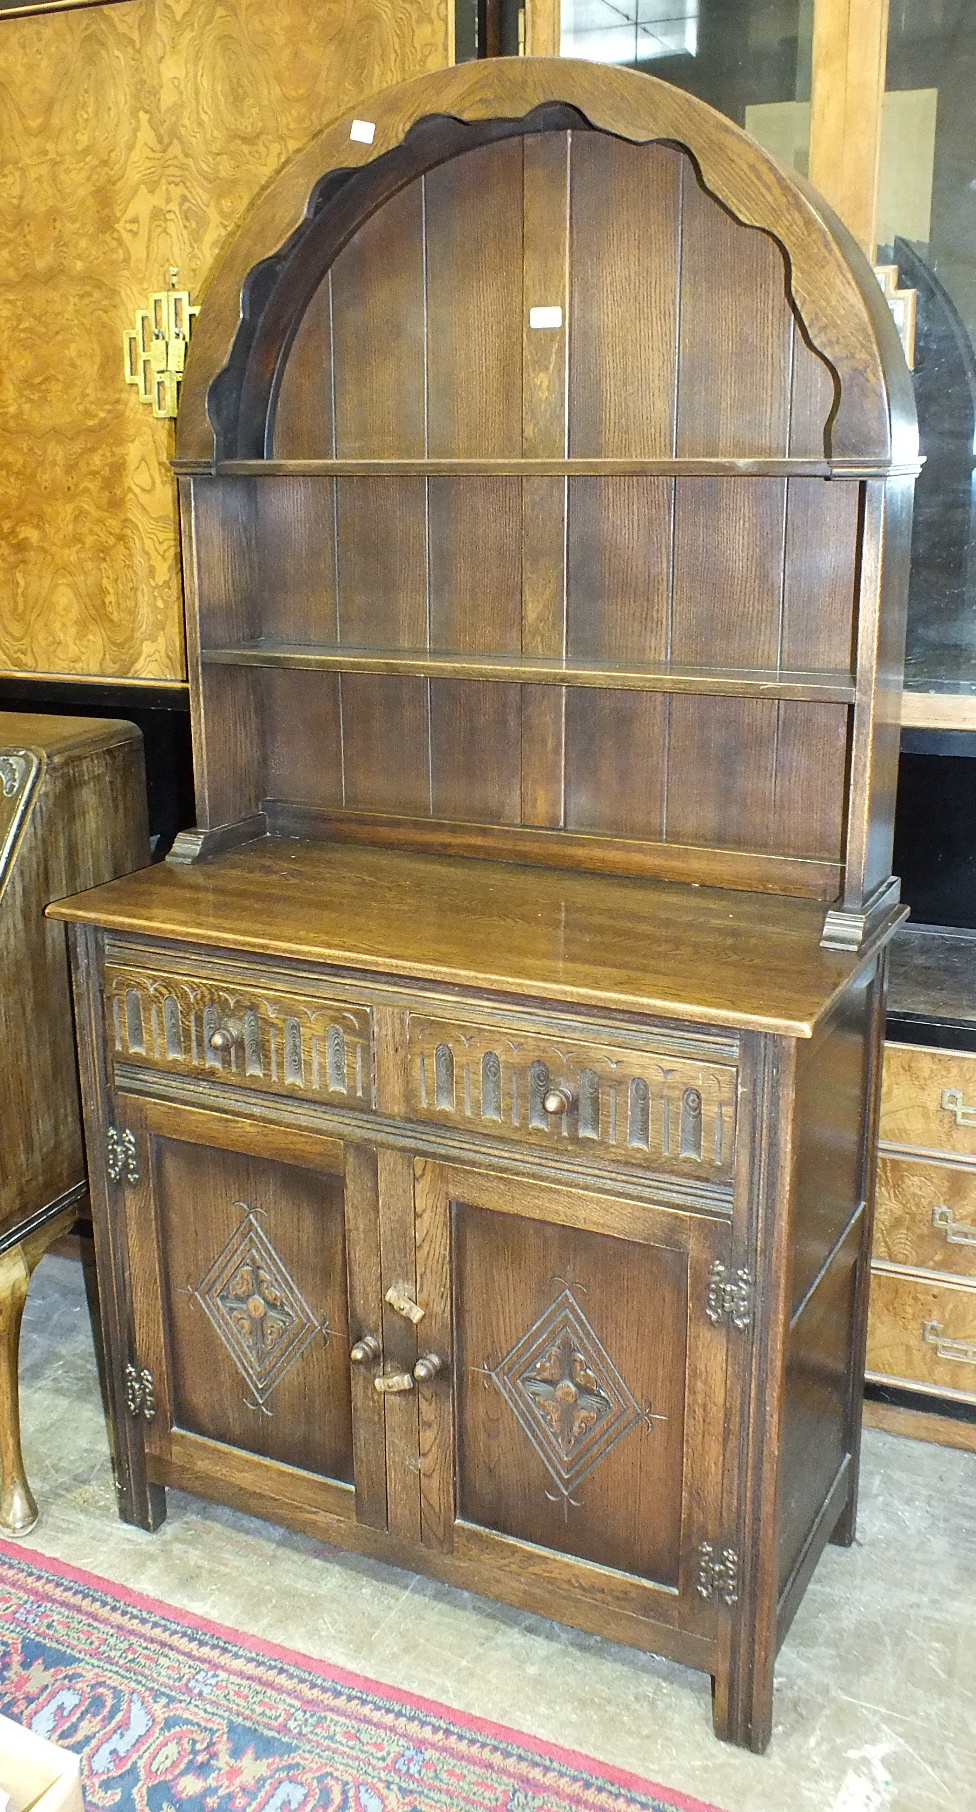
[875,1154,976,1281]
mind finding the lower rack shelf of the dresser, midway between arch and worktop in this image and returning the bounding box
[201,640,855,705]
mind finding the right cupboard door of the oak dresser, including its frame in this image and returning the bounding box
[415,1161,728,1654]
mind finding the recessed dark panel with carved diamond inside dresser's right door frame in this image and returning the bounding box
[453,1185,688,1586]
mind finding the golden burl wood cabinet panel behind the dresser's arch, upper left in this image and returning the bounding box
[0,0,451,680]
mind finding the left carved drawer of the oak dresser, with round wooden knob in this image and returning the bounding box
[105,966,373,1107]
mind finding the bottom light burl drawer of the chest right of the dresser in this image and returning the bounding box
[867,1270,976,1402]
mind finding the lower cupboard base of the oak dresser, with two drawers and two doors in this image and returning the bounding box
[58,852,884,1749]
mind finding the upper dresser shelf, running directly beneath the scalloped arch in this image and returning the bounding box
[172,458,920,478]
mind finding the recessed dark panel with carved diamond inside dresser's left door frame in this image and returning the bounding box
[145,1138,353,1482]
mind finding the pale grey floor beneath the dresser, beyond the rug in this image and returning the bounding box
[9,1258,976,1812]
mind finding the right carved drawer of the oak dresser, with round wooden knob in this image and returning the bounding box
[407,1015,737,1181]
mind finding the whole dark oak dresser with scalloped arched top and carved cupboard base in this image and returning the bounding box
[53,60,916,1749]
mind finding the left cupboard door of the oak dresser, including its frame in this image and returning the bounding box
[120,1096,386,1528]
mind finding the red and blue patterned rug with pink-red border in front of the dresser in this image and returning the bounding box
[0,1542,715,1812]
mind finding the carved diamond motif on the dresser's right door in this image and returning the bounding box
[491,1290,645,1497]
